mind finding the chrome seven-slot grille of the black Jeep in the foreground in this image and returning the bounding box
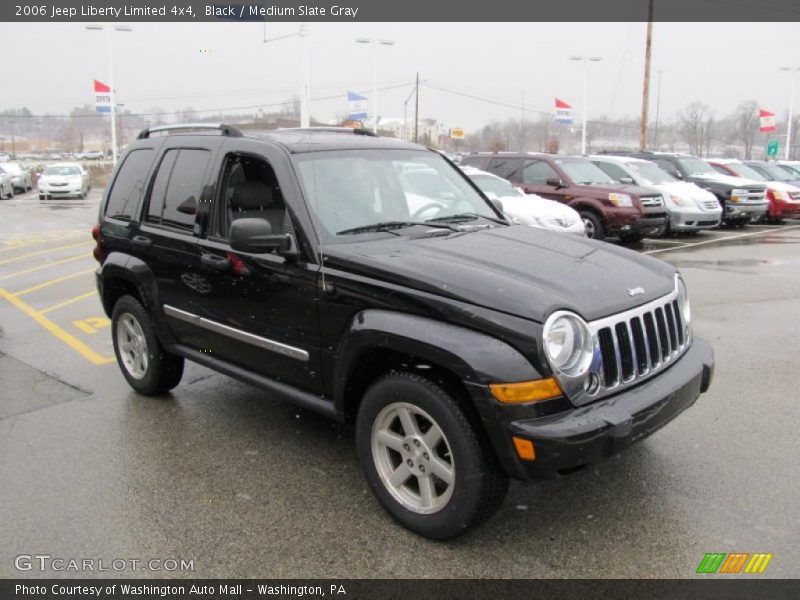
[579,289,691,404]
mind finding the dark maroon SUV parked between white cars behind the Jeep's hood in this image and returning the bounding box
[461,152,667,241]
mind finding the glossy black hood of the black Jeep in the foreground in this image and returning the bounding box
[325,227,675,322]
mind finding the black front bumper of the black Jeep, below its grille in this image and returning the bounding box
[478,338,714,480]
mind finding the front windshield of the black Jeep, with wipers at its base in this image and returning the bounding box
[294,150,498,243]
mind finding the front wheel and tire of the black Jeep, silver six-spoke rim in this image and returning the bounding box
[356,372,508,539]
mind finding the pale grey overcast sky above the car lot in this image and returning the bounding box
[0,23,800,132]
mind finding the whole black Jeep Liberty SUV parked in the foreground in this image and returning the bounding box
[93,125,714,538]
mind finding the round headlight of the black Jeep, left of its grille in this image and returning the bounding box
[544,312,593,377]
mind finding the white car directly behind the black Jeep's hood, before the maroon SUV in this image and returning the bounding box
[461,167,586,235]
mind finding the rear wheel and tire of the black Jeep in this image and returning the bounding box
[111,296,184,396]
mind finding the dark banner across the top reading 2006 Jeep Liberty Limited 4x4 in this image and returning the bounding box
[0,0,800,22]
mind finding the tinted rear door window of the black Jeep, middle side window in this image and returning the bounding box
[147,148,211,230]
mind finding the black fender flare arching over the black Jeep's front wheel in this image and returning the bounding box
[333,309,542,409]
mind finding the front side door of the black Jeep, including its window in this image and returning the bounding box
[193,142,322,393]
